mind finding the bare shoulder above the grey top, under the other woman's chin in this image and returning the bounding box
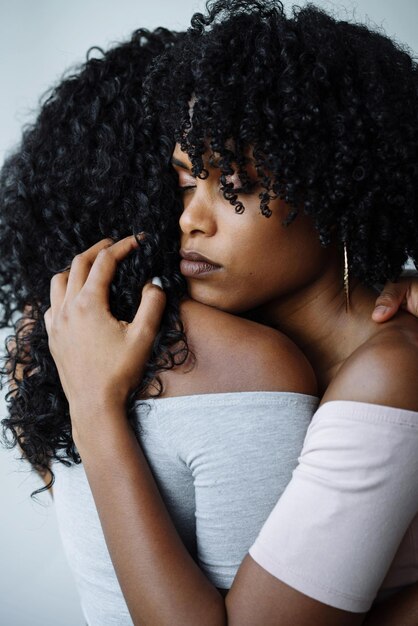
[161,300,316,396]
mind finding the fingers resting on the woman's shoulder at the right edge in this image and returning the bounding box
[372,273,418,322]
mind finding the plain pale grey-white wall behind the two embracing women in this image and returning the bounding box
[0,0,418,626]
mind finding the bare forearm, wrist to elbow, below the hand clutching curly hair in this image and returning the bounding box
[76,409,226,626]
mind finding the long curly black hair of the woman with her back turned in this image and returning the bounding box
[0,28,188,493]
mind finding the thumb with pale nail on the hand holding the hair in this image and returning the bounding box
[128,279,166,354]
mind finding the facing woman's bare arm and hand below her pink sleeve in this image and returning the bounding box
[46,236,418,626]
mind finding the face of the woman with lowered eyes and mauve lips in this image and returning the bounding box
[173,145,329,313]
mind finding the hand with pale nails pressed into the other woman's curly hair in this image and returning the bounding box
[45,236,165,431]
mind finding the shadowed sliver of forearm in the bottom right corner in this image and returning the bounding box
[363,583,418,626]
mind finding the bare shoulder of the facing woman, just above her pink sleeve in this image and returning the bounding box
[323,316,418,411]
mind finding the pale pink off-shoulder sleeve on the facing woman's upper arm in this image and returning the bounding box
[250,402,418,613]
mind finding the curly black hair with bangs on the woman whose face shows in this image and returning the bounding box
[145,0,418,285]
